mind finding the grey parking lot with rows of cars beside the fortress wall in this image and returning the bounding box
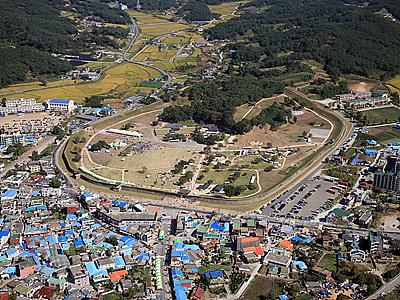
[275,179,338,220]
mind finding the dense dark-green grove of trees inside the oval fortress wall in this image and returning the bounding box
[162,75,290,134]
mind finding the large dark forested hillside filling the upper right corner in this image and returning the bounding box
[206,0,400,79]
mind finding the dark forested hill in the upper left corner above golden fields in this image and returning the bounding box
[0,0,80,87]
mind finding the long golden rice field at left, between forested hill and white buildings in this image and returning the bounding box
[4,63,161,102]
